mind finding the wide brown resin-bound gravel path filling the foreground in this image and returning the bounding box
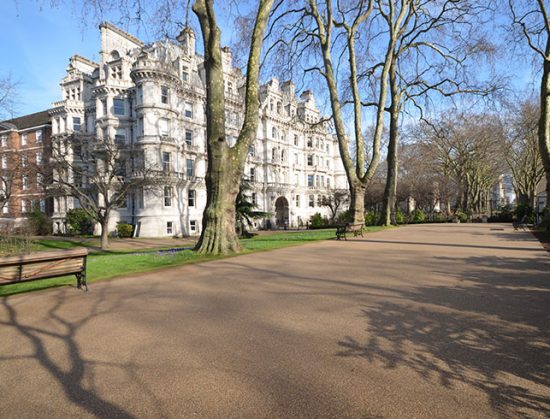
[0,224,550,418]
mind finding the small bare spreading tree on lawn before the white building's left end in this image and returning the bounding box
[49,134,157,249]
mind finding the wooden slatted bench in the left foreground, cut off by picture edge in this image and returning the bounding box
[0,249,88,291]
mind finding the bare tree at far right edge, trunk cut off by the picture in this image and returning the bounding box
[508,0,550,230]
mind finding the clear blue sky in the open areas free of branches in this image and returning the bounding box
[0,0,537,120]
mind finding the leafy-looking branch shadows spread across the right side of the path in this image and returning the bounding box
[337,256,550,416]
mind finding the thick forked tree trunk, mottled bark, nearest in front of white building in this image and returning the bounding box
[193,0,273,254]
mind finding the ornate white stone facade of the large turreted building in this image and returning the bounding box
[50,23,347,237]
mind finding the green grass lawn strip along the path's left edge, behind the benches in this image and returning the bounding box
[0,227,383,296]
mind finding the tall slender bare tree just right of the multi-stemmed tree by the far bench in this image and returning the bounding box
[378,0,496,225]
